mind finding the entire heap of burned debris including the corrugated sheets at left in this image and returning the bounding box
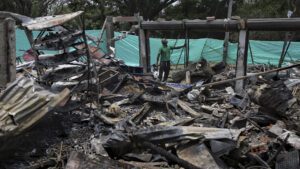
[0,10,300,169]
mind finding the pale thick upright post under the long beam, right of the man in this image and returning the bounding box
[235,30,249,93]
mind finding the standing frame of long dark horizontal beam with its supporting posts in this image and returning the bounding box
[140,18,300,92]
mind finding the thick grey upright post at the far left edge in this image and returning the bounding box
[0,18,16,87]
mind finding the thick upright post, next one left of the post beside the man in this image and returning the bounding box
[105,16,115,53]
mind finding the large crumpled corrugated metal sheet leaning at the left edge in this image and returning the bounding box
[0,77,70,139]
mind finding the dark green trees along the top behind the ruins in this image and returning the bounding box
[0,0,296,40]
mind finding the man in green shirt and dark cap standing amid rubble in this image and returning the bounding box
[156,38,185,81]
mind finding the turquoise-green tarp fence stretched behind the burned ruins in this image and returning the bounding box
[16,29,300,66]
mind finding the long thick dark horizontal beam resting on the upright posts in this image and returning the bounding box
[141,18,300,32]
